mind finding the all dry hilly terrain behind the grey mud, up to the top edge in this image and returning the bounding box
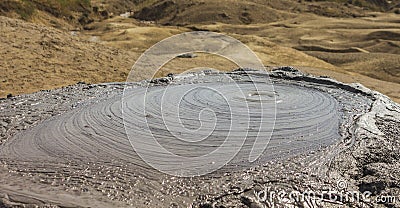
[0,0,400,102]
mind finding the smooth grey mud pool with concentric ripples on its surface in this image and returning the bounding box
[0,82,340,171]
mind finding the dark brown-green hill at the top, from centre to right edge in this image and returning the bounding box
[134,0,395,25]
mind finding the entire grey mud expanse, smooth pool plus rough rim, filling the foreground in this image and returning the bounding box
[0,67,400,207]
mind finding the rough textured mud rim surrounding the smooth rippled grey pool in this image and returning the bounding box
[0,67,400,207]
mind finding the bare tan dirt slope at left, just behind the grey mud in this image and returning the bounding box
[0,16,136,97]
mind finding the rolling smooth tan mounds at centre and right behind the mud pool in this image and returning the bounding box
[79,13,400,102]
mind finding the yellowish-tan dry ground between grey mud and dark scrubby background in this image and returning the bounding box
[0,0,400,102]
